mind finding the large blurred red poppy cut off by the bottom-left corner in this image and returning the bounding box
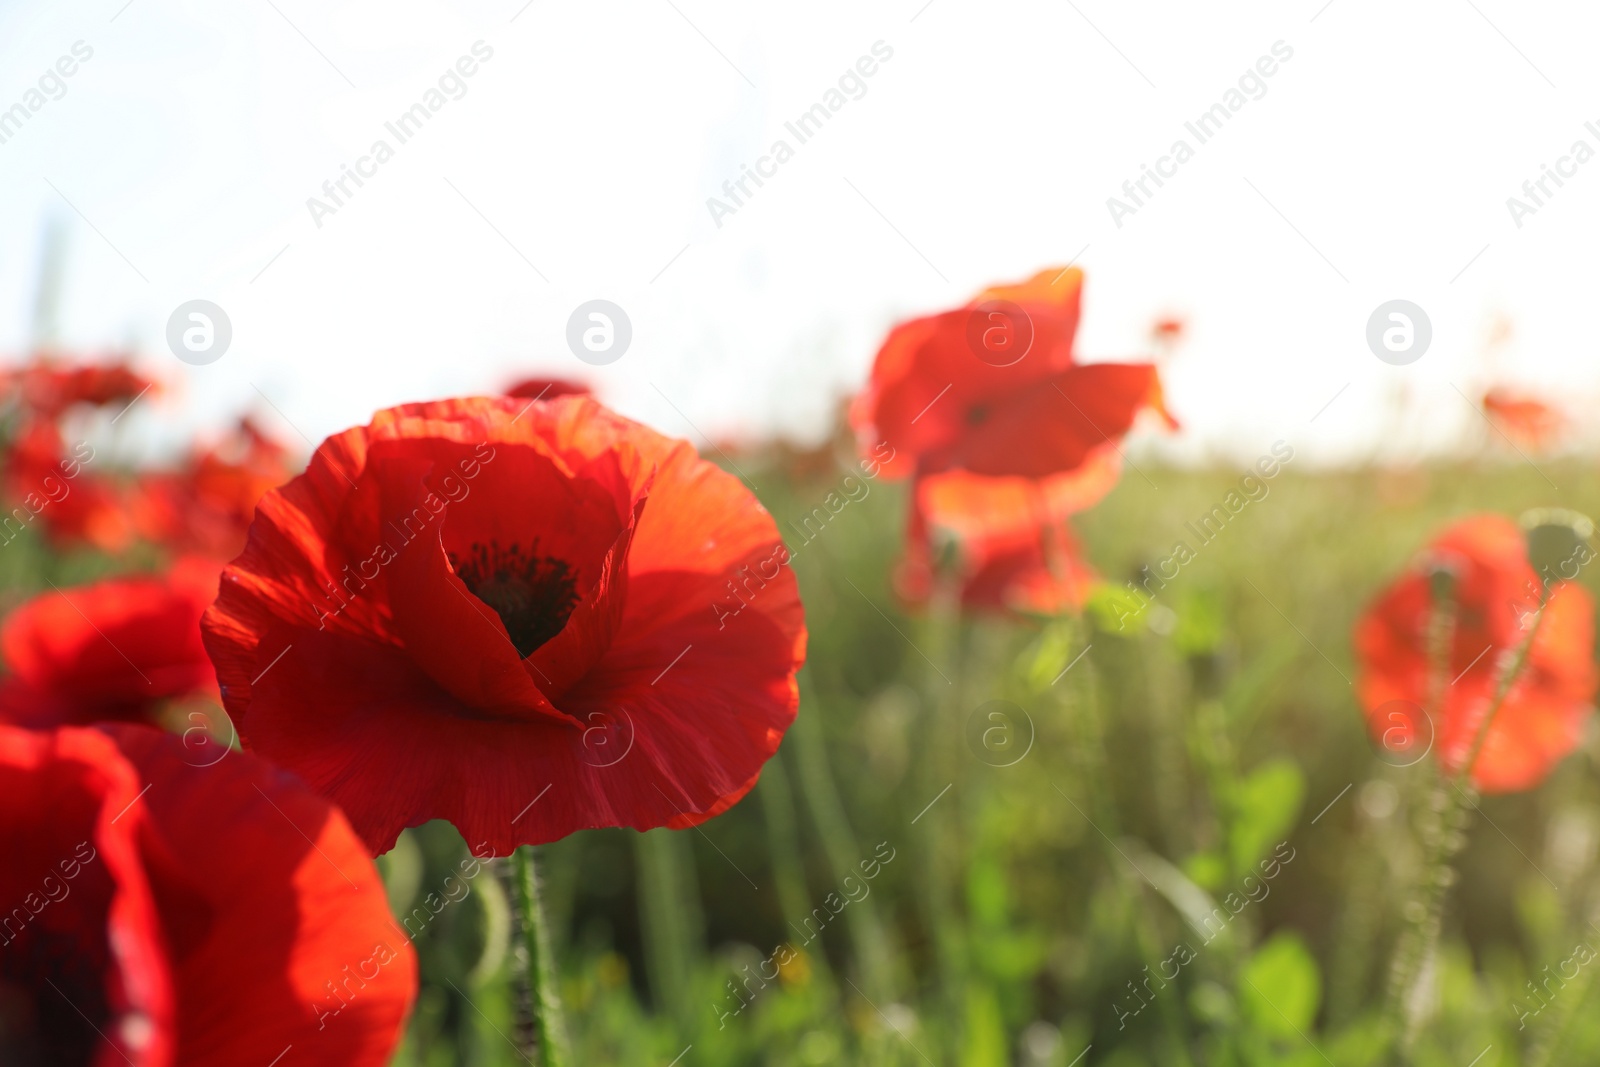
[0,725,416,1067]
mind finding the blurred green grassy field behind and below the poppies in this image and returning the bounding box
[18,448,1580,1067]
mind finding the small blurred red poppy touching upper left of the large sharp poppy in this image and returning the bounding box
[133,419,296,560]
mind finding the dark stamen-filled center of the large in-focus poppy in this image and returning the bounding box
[450,539,578,656]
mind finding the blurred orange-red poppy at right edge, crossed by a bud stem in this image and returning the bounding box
[1355,515,1597,792]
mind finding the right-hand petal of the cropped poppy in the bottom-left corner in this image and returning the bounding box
[106,726,416,1067]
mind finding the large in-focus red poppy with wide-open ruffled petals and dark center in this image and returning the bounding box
[203,397,805,854]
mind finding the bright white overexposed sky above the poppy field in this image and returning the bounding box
[0,0,1600,461]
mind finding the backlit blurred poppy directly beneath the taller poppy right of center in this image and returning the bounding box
[894,445,1122,614]
